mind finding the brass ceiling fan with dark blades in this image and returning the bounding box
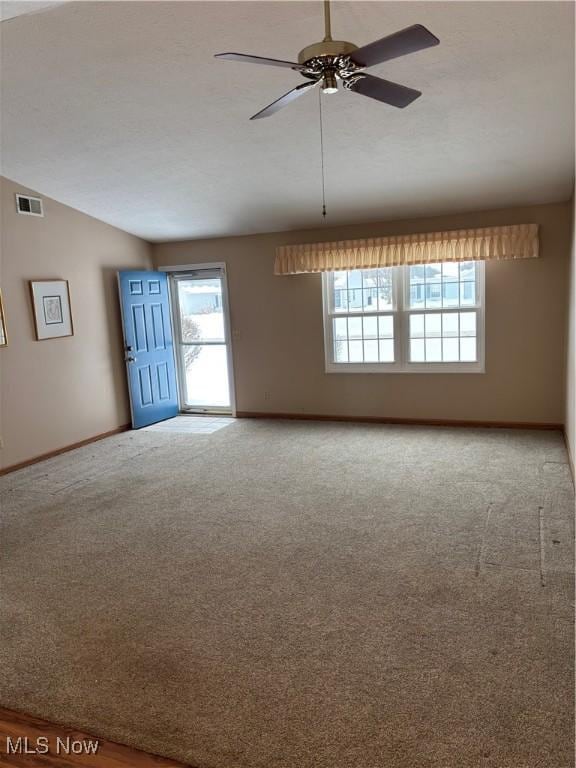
[216,0,440,120]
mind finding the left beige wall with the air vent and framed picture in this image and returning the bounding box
[0,179,150,467]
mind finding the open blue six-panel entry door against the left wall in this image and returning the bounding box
[118,272,179,429]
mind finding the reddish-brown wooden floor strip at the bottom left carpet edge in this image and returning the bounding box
[0,707,194,768]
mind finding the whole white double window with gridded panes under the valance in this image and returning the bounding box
[322,261,484,373]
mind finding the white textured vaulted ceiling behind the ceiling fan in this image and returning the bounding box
[1,2,574,240]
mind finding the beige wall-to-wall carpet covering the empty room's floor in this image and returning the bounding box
[0,421,574,768]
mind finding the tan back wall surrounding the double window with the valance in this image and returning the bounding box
[153,203,570,423]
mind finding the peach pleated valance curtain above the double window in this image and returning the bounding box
[274,224,538,275]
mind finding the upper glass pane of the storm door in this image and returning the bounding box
[177,278,227,342]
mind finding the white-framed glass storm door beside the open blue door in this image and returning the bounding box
[172,268,232,413]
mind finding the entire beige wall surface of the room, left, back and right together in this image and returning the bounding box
[0,185,576,467]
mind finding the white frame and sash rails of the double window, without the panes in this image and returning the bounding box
[322,261,485,373]
